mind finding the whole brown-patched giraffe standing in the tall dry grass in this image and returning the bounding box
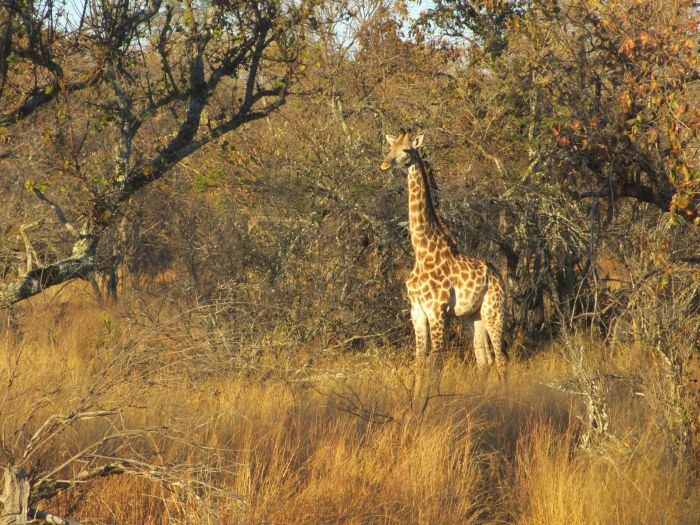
[381,131,508,392]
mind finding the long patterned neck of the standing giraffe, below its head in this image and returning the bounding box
[408,151,456,258]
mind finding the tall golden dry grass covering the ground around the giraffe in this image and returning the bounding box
[0,288,700,524]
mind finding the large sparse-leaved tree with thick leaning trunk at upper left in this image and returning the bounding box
[0,0,310,307]
